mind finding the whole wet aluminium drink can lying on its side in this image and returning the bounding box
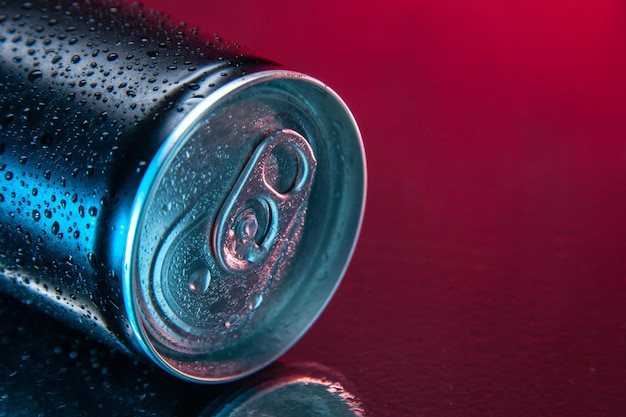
[0,0,365,382]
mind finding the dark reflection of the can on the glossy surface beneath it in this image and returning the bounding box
[0,298,362,417]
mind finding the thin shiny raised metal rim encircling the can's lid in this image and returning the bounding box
[122,70,367,383]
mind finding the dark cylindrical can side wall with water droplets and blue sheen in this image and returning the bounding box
[0,1,269,350]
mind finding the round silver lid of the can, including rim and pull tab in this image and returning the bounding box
[123,70,365,382]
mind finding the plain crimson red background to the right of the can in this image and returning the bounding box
[144,0,626,416]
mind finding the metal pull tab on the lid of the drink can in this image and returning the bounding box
[212,129,317,273]
